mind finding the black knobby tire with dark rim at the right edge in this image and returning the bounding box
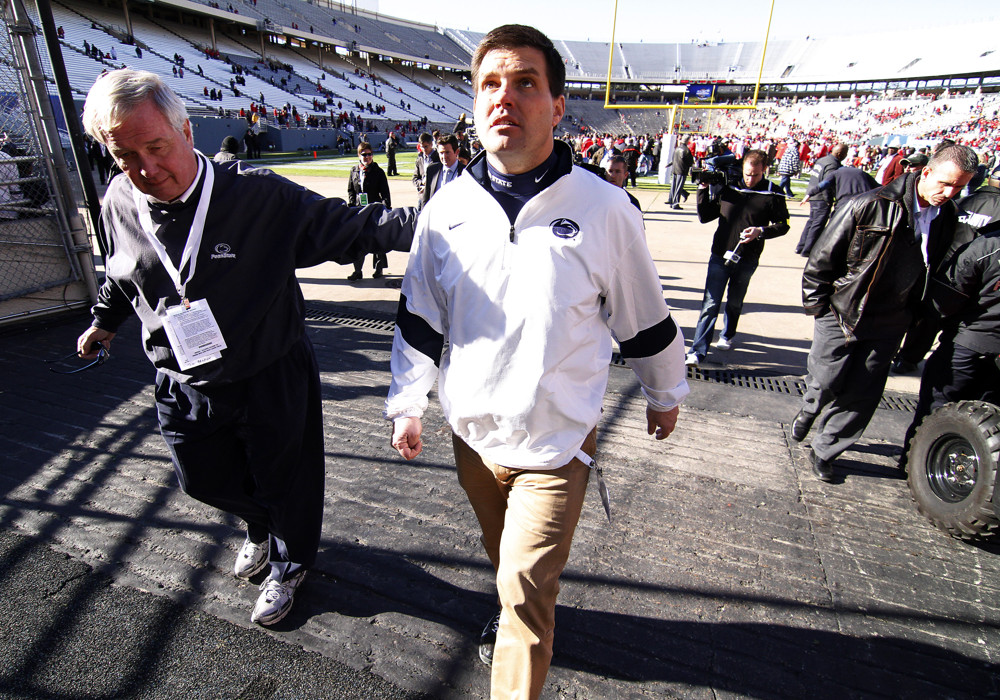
[907,401,1000,540]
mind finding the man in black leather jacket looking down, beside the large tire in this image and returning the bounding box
[791,145,979,481]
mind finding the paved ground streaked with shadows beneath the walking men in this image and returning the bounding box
[0,171,1000,699]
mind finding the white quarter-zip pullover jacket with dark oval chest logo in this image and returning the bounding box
[385,148,688,469]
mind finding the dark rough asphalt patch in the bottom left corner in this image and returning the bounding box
[0,529,418,700]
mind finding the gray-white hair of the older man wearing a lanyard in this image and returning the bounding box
[83,68,188,145]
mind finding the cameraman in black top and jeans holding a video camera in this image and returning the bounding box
[685,150,788,367]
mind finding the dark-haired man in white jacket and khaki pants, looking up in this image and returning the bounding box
[385,25,688,698]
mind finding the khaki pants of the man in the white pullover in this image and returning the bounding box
[452,428,597,700]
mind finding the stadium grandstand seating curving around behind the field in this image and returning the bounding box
[39,0,1000,153]
